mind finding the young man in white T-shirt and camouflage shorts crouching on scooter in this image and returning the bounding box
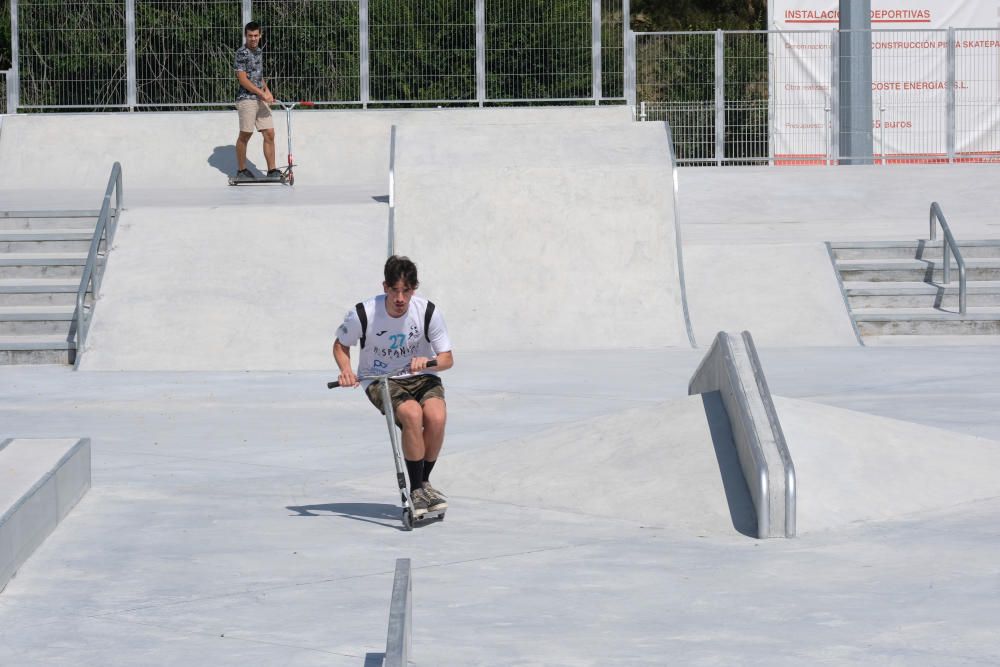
[333,255,454,518]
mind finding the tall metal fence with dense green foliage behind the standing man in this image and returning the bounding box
[8,0,629,110]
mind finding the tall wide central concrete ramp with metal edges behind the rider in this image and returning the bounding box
[396,119,689,350]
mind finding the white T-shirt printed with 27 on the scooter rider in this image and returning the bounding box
[337,294,451,385]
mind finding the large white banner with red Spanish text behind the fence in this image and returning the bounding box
[768,0,1000,164]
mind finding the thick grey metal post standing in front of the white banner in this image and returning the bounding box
[840,0,873,164]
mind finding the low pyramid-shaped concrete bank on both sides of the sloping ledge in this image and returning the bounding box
[435,394,1000,536]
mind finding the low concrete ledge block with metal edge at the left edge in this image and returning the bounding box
[0,438,90,590]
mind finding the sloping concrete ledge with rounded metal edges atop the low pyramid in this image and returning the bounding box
[688,331,796,538]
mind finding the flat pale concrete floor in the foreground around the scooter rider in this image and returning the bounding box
[0,347,1000,667]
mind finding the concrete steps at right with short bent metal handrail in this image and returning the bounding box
[829,240,1000,344]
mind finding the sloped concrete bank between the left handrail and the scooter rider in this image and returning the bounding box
[80,202,386,370]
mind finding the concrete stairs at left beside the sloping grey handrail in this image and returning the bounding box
[0,211,104,364]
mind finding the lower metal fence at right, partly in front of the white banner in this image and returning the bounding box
[628,29,1000,164]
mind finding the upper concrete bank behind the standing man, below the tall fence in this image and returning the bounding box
[0,107,628,196]
